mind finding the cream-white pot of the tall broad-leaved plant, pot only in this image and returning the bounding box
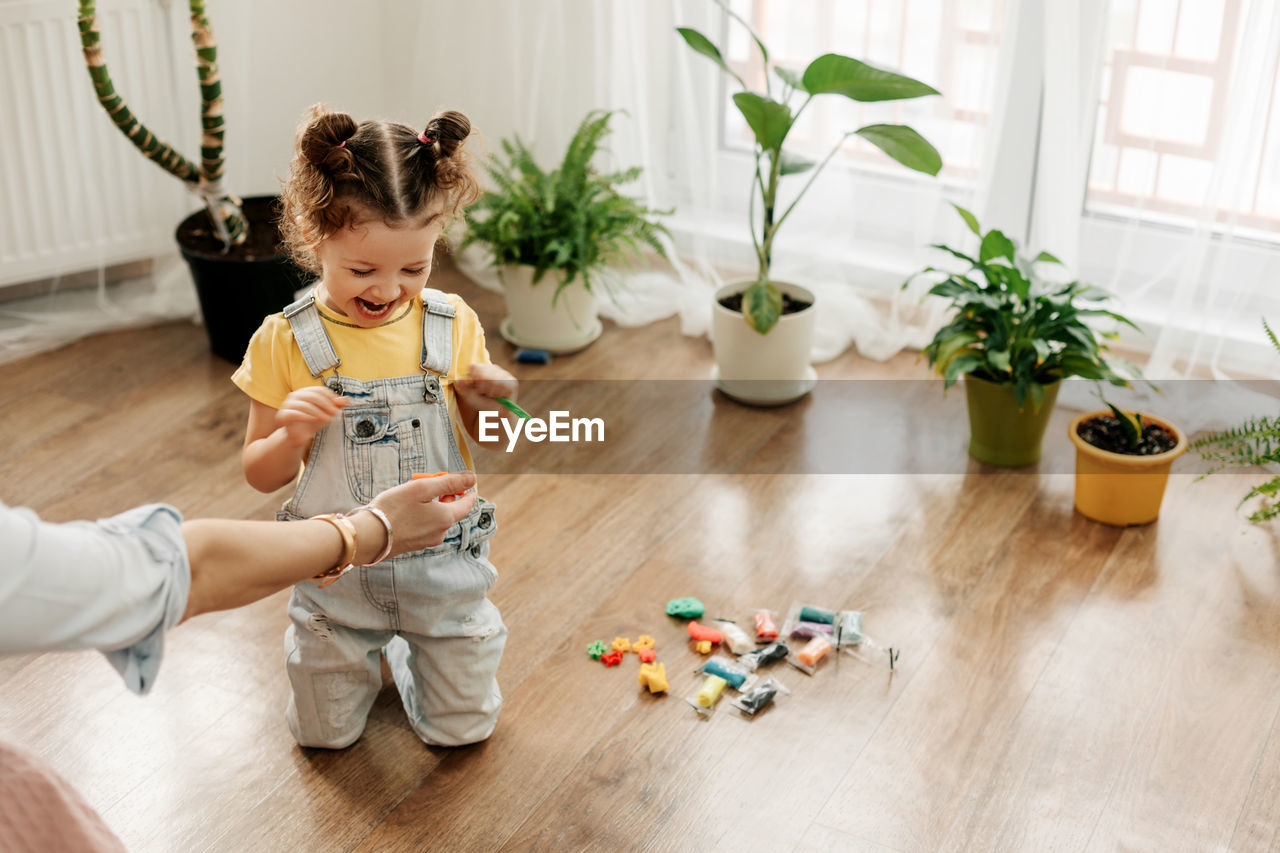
[712,282,818,406]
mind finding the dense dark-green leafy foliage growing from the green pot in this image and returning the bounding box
[902,205,1138,409]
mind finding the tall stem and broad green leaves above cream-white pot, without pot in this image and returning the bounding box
[676,0,942,334]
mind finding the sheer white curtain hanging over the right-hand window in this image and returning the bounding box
[1027,0,1280,430]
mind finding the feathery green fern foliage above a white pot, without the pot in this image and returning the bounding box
[460,110,669,305]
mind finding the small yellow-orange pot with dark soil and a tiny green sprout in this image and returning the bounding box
[1066,401,1187,528]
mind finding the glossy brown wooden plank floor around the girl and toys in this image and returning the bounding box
[0,262,1280,853]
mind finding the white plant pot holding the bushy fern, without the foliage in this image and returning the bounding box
[498,264,604,355]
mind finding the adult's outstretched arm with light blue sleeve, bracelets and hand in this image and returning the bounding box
[0,471,475,693]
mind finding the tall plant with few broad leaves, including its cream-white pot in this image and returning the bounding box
[677,0,942,405]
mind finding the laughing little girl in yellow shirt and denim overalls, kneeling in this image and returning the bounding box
[232,105,516,749]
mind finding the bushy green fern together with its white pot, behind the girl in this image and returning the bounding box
[460,110,669,353]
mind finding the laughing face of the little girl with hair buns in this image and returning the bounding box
[315,215,444,328]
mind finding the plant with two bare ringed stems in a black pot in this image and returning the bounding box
[77,0,303,364]
